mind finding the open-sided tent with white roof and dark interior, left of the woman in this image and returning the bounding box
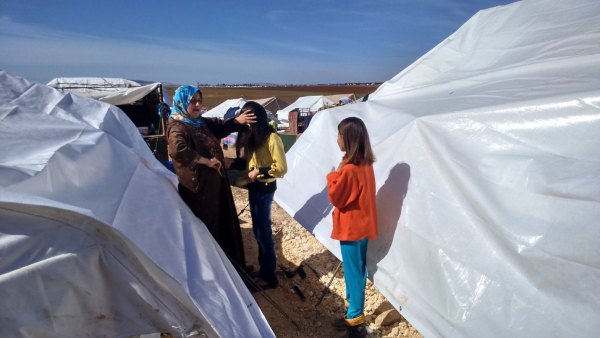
[48,77,173,161]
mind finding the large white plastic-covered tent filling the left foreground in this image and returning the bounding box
[0,71,274,337]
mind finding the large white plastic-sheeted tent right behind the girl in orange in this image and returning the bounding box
[276,0,600,337]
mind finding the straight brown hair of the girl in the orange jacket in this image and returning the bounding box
[338,117,375,165]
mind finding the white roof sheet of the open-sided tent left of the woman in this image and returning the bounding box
[48,77,173,107]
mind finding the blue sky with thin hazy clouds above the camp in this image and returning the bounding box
[0,0,513,84]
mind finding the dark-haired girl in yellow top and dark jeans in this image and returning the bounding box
[237,101,287,289]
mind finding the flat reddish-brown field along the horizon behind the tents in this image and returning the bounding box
[167,85,379,110]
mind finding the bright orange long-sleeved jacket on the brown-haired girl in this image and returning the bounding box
[327,162,377,241]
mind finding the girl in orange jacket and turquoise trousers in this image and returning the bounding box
[327,117,377,335]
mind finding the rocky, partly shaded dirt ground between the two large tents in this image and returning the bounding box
[226,149,422,338]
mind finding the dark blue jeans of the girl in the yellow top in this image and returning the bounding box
[248,190,277,283]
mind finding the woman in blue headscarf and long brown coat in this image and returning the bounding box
[167,85,256,268]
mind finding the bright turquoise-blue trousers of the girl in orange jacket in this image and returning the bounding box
[340,238,369,319]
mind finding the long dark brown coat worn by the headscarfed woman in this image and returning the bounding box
[167,118,246,267]
